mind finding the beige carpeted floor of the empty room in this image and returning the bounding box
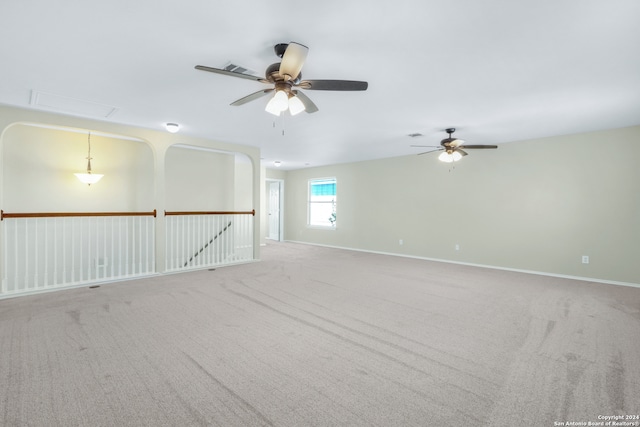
[0,243,640,427]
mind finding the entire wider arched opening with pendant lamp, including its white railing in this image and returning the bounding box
[0,123,155,296]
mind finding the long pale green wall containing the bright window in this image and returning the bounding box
[285,127,640,284]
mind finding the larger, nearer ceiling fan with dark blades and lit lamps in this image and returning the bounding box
[195,42,368,116]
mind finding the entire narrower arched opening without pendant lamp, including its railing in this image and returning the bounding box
[164,144,256,272]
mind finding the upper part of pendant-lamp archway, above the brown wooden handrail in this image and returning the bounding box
[2,123,154,212]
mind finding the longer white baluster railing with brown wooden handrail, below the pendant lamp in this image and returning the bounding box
[0,211,155,296]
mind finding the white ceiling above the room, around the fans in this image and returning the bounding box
[0,0,640,169]
